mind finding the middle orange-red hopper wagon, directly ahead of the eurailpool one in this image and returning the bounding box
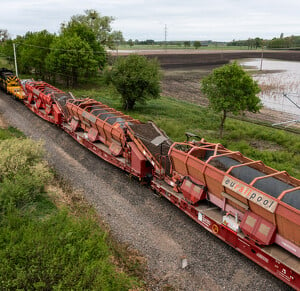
[63,99,169,180]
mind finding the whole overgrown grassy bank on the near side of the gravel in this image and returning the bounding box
[0,128,143,290]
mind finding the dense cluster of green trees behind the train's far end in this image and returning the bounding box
[0,10,123,86]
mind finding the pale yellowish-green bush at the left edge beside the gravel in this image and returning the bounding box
[0,138,52,213]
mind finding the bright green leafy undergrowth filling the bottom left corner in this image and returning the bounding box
[0,212,137,290]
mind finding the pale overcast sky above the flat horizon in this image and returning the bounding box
[0,0,300,41]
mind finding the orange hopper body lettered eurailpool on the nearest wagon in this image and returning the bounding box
[169,140,300,250]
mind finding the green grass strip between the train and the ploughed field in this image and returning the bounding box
[72,86,300,179]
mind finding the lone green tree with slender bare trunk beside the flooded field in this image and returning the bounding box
[201,62,262,138]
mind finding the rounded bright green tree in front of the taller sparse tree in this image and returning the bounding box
[46,35,98,86]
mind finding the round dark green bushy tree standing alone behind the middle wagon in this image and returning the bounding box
[111,54,161,110]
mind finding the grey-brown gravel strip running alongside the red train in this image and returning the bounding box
[0,92,290,291]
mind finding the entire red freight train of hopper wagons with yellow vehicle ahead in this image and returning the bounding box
[0,69,300,289]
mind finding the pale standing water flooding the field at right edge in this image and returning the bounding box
[239,59,300,115]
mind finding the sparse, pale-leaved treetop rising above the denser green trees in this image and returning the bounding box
[69,10,124,49]
